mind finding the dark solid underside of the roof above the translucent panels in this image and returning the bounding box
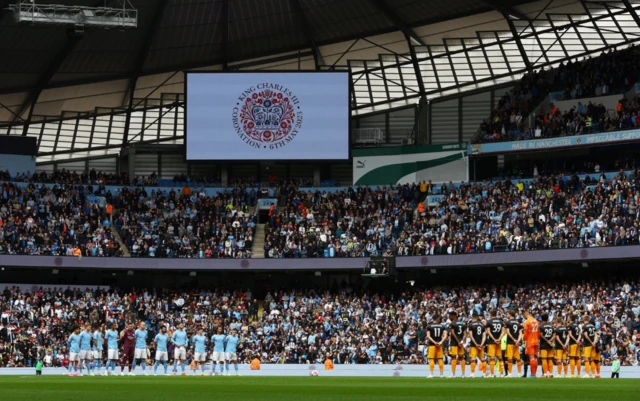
[0,0,531,93]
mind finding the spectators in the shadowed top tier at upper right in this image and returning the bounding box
[473,46,640,142]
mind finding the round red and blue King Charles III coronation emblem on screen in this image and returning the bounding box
[232,83,303,150]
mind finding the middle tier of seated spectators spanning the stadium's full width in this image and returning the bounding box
[0,163,640,258]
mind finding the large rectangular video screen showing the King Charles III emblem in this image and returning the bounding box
[185,72,349,161]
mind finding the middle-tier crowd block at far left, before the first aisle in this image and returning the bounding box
[0,182,122,256]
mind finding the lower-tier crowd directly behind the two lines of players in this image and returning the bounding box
[0,279,640,367]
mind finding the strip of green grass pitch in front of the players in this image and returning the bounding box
[0,375,640,401]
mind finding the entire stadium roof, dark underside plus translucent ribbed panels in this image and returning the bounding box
[0,0,640,164]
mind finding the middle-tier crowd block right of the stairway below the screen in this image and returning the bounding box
[264,170,640,258]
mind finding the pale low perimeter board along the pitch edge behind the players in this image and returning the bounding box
[0,364,640,380]
